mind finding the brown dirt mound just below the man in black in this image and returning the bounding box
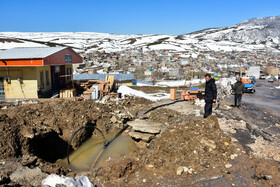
[140,116,233,172]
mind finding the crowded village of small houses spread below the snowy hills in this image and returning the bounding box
[75,49,280,81]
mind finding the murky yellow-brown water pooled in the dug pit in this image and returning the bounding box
[57,134,136,170]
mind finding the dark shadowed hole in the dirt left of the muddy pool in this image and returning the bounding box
[29,131,68,163]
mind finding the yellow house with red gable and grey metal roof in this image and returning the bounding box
[0,47,83,100]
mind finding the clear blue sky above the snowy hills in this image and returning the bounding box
[0,0,280,35]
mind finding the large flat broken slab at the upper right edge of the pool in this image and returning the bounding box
[127,120,164,134]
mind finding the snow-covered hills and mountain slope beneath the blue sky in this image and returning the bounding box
[0,16,280,52]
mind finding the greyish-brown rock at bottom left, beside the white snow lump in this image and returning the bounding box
[10,166,48,186]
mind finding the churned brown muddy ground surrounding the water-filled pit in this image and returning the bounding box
[0,84,280,186]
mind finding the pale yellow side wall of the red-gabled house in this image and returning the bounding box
[0,67,38,99]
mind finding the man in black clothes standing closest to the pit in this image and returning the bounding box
[204,73,217,118]
